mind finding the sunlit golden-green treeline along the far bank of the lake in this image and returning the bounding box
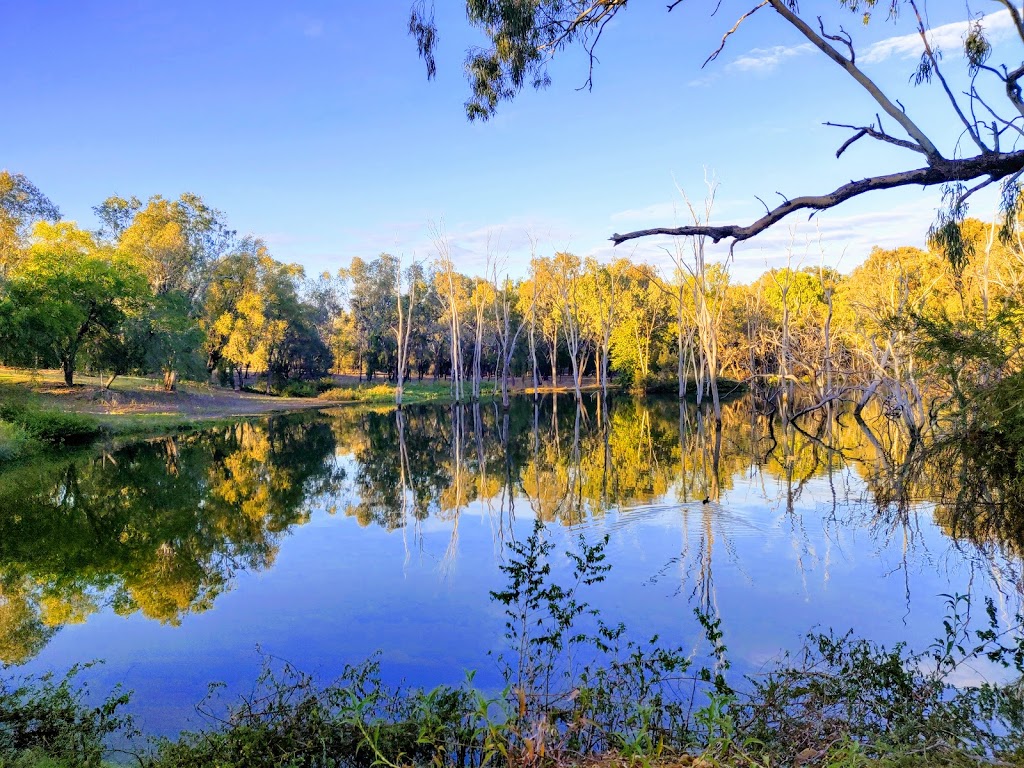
[0,172,1024,431]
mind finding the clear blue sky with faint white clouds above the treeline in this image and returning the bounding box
[0,0,1007,280]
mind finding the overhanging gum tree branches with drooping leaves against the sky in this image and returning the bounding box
[409,0,1024,250]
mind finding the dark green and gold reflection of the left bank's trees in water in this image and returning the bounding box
[0,419,341,664]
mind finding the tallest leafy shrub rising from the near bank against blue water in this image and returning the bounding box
[490,520,689,763]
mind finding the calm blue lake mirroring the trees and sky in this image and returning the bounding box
[0,395,1021,734]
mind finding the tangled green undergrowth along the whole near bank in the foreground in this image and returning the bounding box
[0,524,1024,768]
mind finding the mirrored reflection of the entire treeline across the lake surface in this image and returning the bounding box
[0,396,1024,664]
